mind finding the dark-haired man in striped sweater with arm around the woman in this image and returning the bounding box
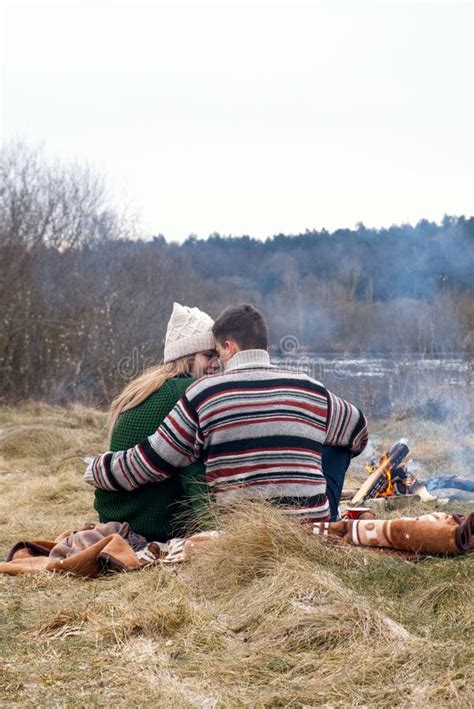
[86,304,367,521]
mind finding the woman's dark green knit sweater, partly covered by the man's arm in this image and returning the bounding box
[94,377,208,541]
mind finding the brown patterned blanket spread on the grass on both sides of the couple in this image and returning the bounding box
[0,512,474,578]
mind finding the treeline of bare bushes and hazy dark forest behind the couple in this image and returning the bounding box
[0,144,474,404]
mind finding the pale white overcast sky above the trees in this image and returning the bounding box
[0,0,473,240]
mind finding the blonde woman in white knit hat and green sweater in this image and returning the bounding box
[94,303,218,541]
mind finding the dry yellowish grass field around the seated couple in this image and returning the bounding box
[0,403,474,708]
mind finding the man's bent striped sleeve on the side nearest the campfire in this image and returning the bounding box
[325,391,368,456]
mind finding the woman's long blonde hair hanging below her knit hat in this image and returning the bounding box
[107,355,194,438]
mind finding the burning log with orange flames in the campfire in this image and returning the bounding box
[351,438,410,505]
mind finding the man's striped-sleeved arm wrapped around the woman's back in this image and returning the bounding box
[84,394,203,490]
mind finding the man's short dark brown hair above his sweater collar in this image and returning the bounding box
[212,303,268,350]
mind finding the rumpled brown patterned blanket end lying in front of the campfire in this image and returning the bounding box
[313,512,474,554]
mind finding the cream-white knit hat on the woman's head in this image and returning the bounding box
[164,303,216,362]
